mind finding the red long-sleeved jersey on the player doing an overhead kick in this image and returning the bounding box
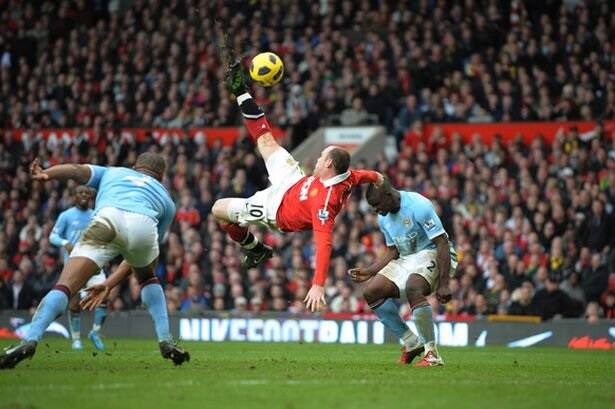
[276,170,378,285]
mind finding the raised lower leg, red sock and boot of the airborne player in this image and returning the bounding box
[224,60,280,160]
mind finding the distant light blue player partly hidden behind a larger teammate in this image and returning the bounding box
[49,186,107,351]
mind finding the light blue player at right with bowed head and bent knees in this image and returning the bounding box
[349,181,457,366]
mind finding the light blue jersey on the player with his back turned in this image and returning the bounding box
[87,165,175,241]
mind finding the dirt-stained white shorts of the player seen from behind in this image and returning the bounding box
[70,207,160,268]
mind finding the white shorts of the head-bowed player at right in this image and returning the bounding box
[378,250,457,299]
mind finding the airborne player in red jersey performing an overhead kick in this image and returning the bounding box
[212,62,383,311]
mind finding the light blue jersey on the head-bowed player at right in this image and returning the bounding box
[378,191,448,256]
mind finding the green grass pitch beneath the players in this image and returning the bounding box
[0,339,615,409]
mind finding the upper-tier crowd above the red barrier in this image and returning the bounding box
[0,0,615,141]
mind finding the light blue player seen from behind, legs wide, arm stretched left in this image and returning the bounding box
[0,153,190,369]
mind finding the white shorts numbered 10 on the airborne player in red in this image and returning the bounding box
[228,148,305,229]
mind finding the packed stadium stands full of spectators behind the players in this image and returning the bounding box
[0,0,615,328]
